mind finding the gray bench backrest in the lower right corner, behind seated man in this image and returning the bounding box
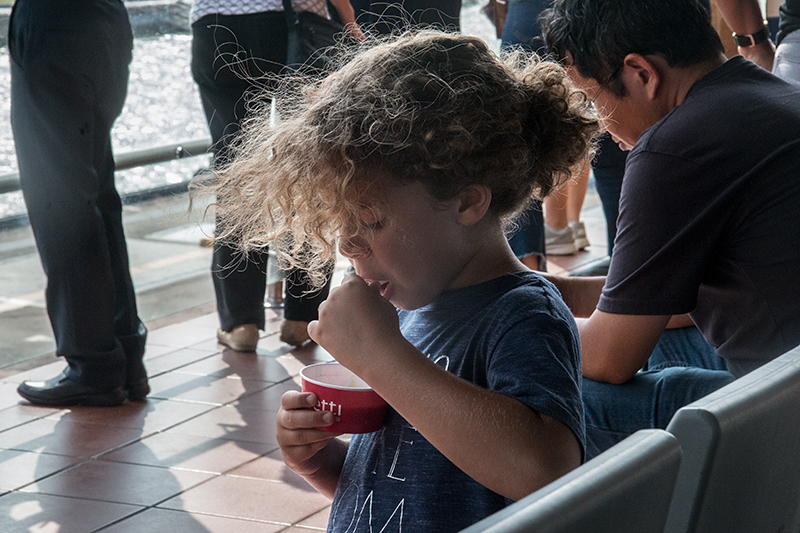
[665,347,800,533]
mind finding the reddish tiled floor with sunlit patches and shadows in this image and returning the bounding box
[0,204,605,533]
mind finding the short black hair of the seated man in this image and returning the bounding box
[541,0,725,96]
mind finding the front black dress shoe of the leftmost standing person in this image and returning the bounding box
[17,367,127,407]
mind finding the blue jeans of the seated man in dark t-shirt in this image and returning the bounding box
[583,327,734,460]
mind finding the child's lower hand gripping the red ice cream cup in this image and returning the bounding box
[275,391,339,477]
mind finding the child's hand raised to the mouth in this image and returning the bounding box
[308,274,406,375]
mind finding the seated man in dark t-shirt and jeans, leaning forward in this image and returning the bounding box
[543,0,800,456]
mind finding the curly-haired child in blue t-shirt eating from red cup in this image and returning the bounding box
[209,31,598,533]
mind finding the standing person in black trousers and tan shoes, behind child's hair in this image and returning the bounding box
[191,0,363,352]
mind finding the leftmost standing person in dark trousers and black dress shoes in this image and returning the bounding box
[8,0,150,406]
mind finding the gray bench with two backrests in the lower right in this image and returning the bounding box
[462,346,800,533]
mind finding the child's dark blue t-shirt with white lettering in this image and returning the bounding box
[328,272,584,533]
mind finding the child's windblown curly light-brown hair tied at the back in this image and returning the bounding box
[203,30,599,281]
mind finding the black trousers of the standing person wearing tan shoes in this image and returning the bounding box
[192,11,330,331]
